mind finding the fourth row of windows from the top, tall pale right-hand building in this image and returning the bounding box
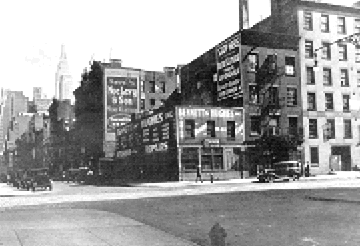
[307,92,350,112]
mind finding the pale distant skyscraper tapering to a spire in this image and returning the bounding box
[55,45,73,101]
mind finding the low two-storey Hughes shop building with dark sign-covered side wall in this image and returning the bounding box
[113,106,248,181]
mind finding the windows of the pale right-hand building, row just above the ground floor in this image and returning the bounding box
[309,119,352,139]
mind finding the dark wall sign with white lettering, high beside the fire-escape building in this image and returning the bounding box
[215,34,242,101]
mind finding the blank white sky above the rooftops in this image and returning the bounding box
[0,0,354,98]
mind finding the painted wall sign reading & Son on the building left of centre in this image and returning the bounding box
[106,77,138,133]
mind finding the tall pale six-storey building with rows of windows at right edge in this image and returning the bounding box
[253,0,360,174]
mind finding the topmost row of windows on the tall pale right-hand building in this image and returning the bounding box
[304,11,360,34]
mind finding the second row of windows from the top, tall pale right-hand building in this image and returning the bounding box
[305,40,360,63]
